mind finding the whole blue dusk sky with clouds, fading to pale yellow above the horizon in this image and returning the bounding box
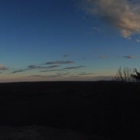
[0,0,140,82]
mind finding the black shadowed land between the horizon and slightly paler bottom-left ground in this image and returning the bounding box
[0,82,140,140]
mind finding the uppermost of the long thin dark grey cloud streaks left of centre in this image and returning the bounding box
[45,60,74,65]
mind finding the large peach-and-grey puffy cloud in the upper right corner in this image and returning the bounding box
[82,0,140,38]
